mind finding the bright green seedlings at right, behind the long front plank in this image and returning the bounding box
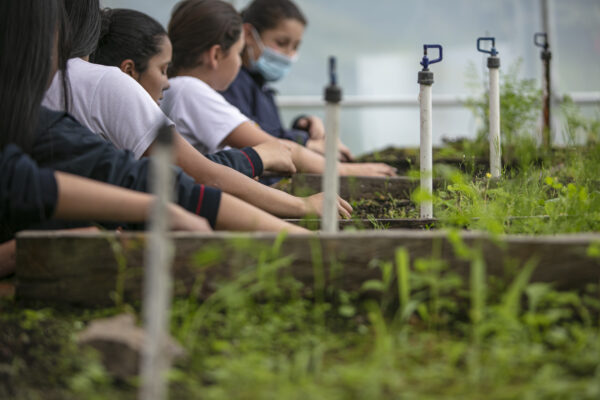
[434,145,600,234]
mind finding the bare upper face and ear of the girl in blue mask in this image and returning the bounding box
[244,18,304,61]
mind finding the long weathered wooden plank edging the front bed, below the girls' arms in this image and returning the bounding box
[16,230,600,306]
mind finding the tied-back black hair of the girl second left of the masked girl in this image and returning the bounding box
[90,8,167,74]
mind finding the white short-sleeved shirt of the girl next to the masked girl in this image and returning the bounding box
[160,76,249,154]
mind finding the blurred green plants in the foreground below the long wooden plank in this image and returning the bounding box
[0,234,600,399]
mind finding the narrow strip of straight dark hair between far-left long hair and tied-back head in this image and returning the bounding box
[63,0,102,58]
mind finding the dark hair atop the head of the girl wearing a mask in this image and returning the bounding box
[242,0,308,34]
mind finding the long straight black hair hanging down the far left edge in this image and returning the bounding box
[0,0,67,152]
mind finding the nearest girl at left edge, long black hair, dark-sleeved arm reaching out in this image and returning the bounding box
[0,0,210,277]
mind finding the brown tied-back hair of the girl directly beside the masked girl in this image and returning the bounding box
[169,0,242,76]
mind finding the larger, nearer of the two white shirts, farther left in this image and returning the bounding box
[42,58,173,158]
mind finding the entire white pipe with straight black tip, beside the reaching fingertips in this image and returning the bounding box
[323,57,342,233]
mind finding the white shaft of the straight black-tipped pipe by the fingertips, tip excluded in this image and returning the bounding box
[321,103,340,233]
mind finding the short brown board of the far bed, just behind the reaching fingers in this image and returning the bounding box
[292,174,443,200]
